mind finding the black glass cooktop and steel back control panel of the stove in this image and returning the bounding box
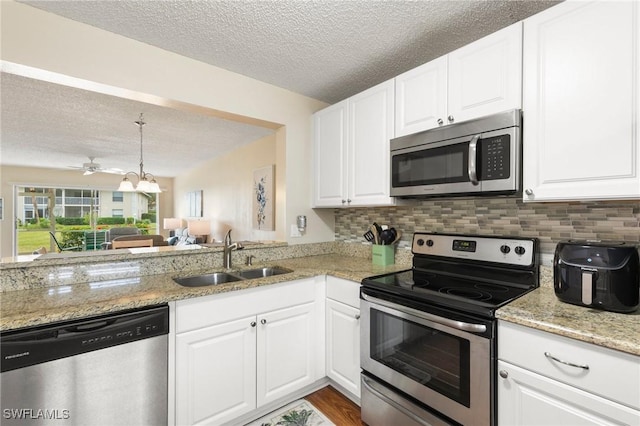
[362,233,538,316]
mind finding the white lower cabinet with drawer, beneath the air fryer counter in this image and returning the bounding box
[497,321,640,426]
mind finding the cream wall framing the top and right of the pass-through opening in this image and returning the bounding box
[0,1,334,256]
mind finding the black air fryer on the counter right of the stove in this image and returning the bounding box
[553,241,640,312]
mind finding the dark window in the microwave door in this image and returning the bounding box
[391,142,469,187]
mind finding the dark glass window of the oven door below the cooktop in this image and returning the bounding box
[370,309,470,407]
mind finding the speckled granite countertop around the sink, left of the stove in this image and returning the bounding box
[0,254,410,331]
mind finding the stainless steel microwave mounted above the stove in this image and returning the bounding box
[390,109,522,197]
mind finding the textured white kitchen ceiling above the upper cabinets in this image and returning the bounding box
[21,0,554,103]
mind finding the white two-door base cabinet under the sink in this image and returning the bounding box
[175,279,325,425]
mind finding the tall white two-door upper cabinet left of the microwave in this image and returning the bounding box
[314,80,394,207]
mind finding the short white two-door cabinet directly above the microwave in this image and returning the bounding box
[395,22,522,137]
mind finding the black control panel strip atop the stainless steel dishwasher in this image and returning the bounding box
[0,305,169,372]
